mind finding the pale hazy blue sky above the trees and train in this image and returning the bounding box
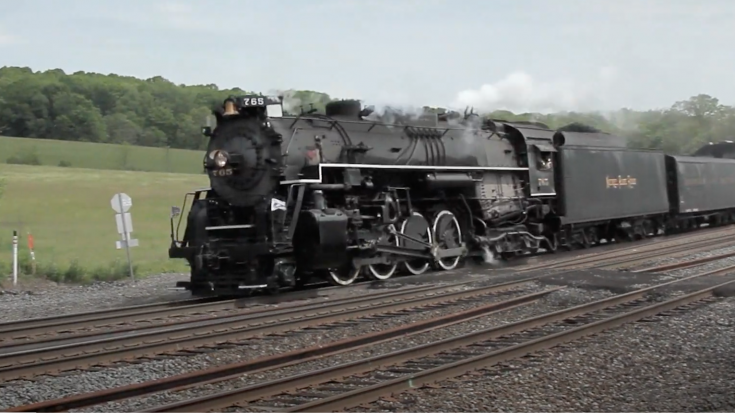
[0,0,735,112]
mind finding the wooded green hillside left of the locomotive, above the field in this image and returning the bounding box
[0,67,329,149]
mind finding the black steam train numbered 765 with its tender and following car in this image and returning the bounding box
[169,95,735,295]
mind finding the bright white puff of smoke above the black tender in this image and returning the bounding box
[452,67,616,113]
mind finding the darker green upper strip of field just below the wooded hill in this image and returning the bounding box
[0,136,203,174]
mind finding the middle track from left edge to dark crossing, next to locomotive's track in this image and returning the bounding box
[0,278,548,381]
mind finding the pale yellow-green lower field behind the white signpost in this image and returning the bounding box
[0,163,209,282]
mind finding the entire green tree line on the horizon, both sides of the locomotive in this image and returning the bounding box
[0,67,735,154]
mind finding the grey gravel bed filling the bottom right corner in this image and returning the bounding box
[351,298,735,412]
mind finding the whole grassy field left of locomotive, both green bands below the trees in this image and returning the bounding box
[0,137,208,282]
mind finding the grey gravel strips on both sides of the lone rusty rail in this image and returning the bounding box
[0,286,610,411]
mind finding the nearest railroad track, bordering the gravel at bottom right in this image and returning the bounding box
[145,266,735,412]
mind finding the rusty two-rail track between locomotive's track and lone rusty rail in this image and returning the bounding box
[0,277,538,380]
